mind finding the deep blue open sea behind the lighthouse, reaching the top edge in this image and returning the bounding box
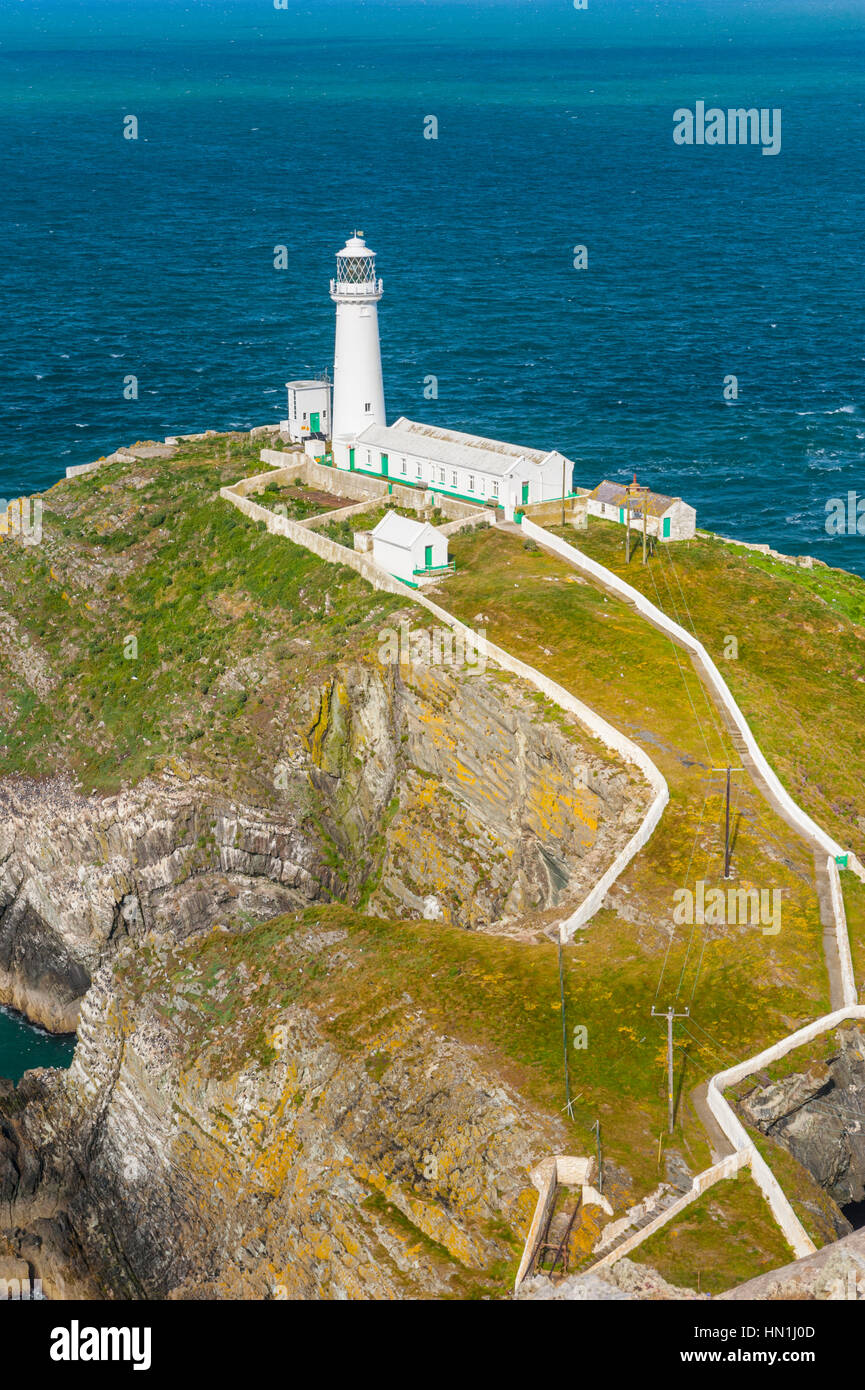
[0,0,865,573]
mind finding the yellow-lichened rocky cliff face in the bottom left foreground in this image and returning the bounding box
[0,912,563,1298]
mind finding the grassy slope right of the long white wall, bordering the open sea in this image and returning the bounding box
[562,518,865,855]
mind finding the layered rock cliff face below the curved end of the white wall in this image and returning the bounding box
[0,663,645,1031]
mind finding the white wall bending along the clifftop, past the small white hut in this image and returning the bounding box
[220,466,670,941]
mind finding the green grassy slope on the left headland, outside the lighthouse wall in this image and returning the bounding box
[0,436,410,799]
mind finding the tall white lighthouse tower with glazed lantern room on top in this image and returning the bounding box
[331,234,387,439]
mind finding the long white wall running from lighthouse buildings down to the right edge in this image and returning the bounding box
[522,517,865,883]
